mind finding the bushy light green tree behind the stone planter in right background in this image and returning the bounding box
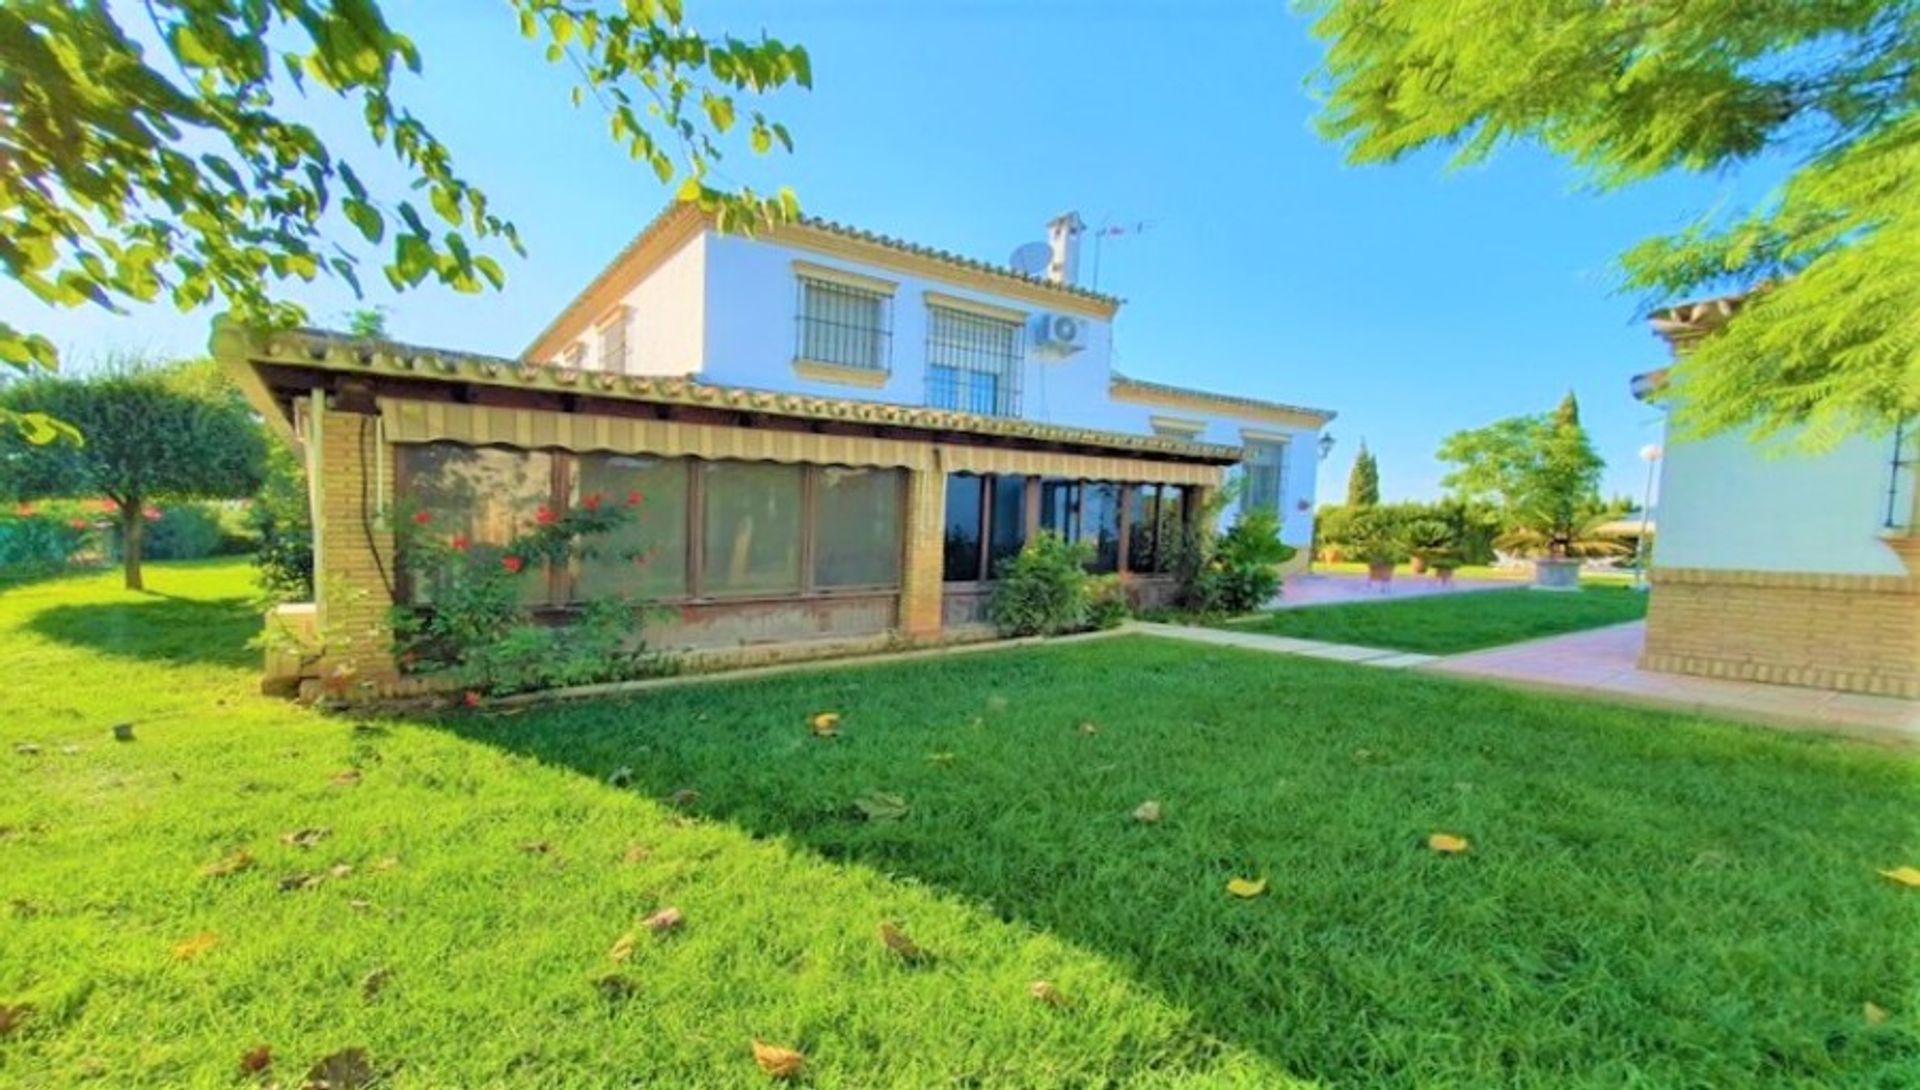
[1440,393,1607,557]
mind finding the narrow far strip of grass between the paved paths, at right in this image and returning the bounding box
[1227,587,1647,654]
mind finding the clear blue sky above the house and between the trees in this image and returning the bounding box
[0,0,1778,499]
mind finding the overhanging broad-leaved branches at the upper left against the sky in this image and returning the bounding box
[0,0,812,441]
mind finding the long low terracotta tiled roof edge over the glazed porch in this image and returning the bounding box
[213,326,1240,464]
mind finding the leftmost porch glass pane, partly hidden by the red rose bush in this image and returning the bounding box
[396,443,553,603]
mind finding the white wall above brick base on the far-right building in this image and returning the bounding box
[1653,434,1910,576]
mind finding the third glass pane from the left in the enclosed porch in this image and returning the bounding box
[699,462,803,595]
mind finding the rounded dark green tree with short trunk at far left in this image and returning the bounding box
[0,362,267,589]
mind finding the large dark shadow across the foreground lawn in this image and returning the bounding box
[445,639,1920,1088]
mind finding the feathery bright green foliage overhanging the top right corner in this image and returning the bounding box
[1308,0,1920,445]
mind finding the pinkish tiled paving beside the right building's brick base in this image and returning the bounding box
[1419,622,1920,745]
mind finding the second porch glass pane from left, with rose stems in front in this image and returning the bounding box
[572,455,687,601]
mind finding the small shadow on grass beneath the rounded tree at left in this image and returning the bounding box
[27,593,261,668]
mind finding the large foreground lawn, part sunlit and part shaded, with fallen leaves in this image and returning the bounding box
[0,564,1920,1090]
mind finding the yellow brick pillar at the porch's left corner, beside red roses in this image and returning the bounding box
[307,393,396,687]
